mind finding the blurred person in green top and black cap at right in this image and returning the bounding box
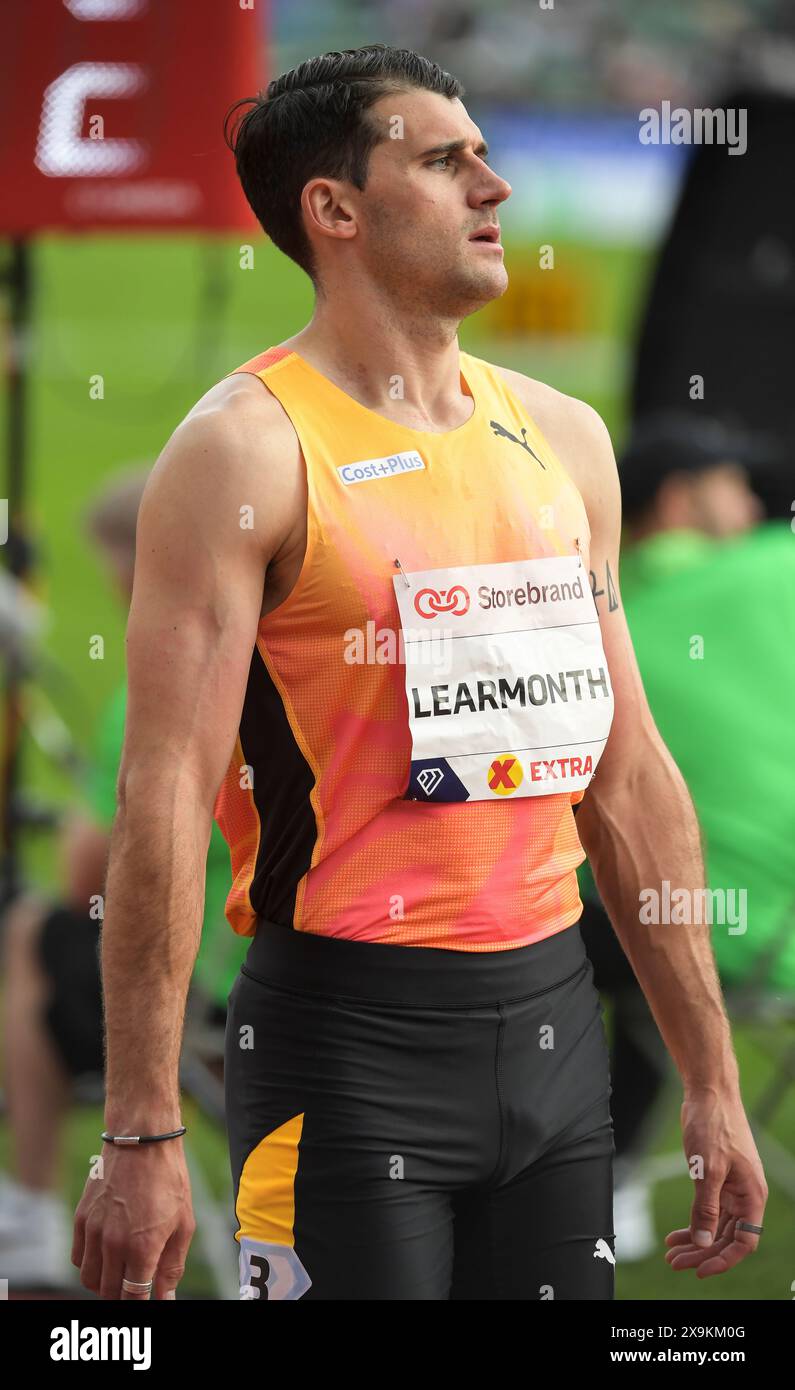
[580,413,795,1261]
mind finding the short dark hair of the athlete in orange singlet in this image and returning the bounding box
[224,43,464,278]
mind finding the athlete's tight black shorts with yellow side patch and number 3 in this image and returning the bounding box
[225,922,614,1300]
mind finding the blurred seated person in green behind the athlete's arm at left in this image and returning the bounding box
[0,468,245,1286]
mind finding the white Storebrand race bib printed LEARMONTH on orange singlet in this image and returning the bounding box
[392,555,614,802]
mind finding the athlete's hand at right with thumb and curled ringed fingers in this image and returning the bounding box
[666,1091,767,1279]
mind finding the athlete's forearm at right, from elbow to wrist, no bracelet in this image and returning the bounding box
[577,737,738,1091]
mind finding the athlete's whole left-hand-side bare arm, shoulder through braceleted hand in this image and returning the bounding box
[72,377,297,1298]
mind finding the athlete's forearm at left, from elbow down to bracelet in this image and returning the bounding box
[101,788,210,1133]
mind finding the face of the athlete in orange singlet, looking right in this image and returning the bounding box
[354,92,511,317]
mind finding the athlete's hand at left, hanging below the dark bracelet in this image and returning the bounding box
[72,1138,196,1301]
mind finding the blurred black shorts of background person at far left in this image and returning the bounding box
[39,906,104,1077]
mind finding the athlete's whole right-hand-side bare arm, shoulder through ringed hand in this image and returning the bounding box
[506,373,767,1277]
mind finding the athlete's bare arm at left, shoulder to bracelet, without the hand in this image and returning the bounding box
[103,386,289,1133]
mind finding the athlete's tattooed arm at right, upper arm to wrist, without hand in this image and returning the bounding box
[561,413,738,1093]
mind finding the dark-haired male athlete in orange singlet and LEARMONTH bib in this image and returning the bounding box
[74,46,766,1300]
